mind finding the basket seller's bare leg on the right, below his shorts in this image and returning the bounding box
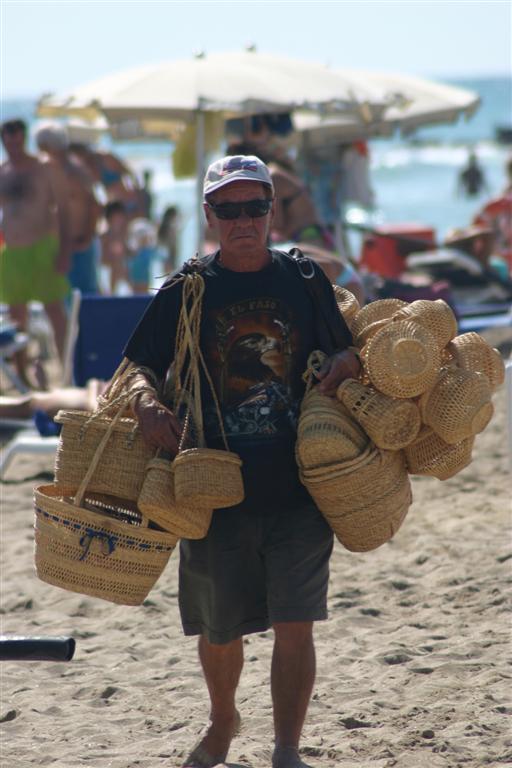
[271,622,316,768]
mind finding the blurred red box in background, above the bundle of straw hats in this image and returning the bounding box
[360,222,435,278]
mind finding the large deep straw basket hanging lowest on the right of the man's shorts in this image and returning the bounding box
[301,449,412,552]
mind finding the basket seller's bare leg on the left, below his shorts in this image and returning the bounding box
[185,636,244,765]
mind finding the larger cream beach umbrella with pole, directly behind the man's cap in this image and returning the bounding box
[37,50,395,248]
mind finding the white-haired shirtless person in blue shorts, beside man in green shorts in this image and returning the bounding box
[36,123,99,293]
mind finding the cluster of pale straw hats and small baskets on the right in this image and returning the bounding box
[338,299,505,480]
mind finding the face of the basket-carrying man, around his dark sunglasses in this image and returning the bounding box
[204,181,274,253]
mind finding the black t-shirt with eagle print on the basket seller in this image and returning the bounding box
[125,252,342,505]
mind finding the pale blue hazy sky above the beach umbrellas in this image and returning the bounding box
[0,0,512,99]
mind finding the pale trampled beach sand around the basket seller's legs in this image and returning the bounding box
[0,333,512,768]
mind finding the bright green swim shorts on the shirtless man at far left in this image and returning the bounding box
[0,234,70,304]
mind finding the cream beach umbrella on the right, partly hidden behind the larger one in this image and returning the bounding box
[293,71,480,147]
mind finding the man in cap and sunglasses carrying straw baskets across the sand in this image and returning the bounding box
[125,156,359,768]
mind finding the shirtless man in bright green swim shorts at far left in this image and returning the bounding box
[0,120,69,386]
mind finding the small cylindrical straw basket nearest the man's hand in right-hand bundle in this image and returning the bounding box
[337,379,421,451]
